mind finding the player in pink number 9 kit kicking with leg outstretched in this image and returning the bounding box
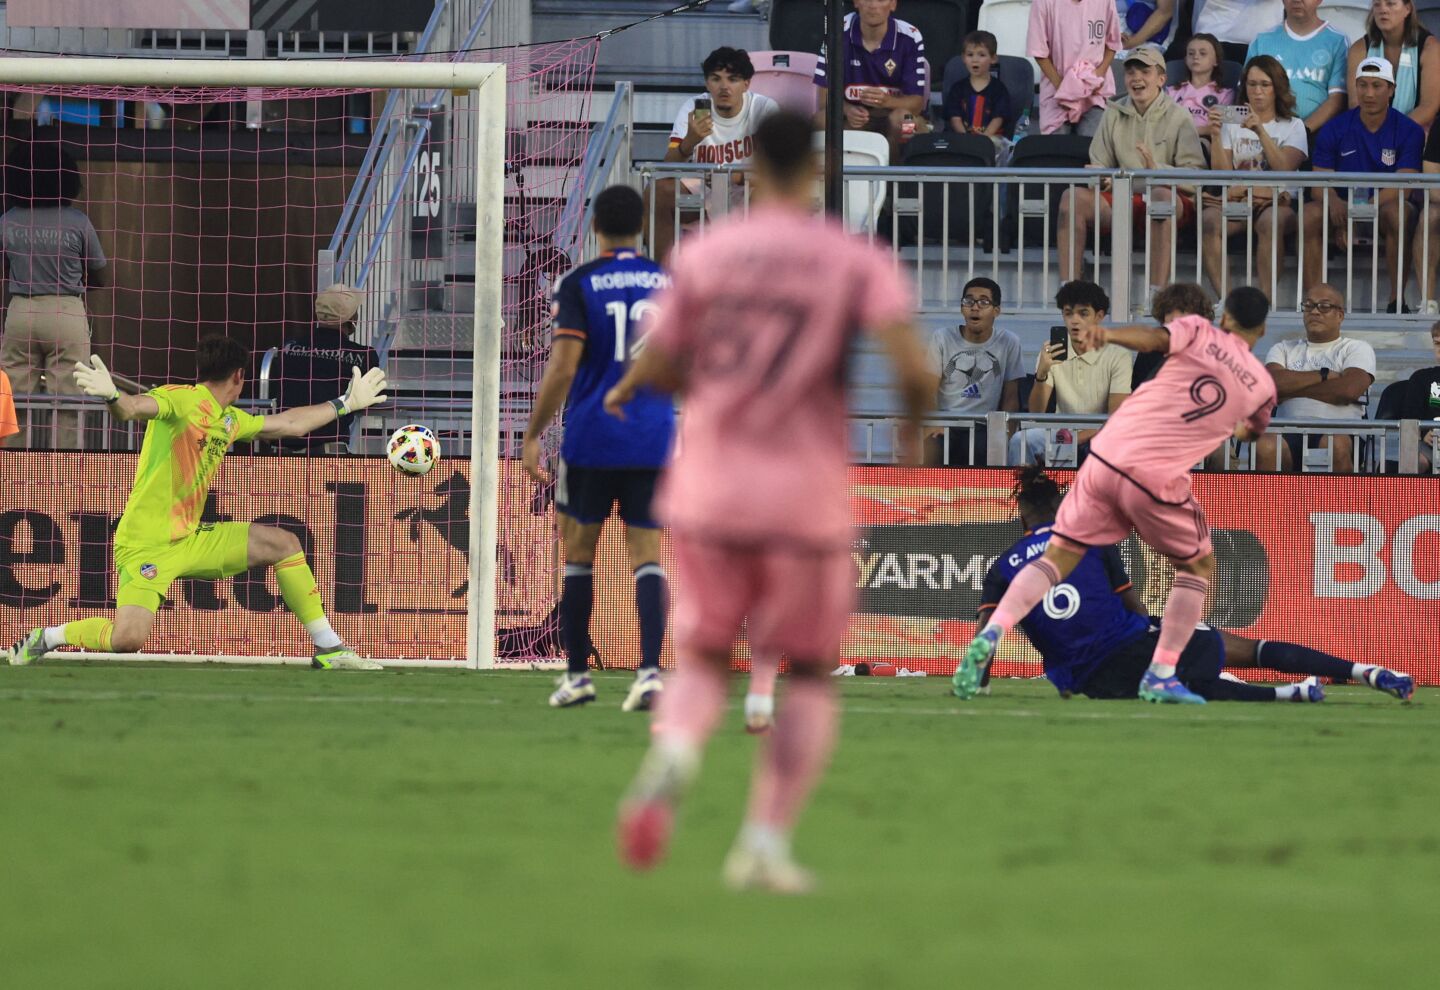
[955,286,1276,705]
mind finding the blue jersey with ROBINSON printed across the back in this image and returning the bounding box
[554,250,675,469]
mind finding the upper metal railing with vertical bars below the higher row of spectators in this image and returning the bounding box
[634,163,1440,319]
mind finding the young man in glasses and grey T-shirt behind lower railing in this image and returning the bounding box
[926,276,1025,468]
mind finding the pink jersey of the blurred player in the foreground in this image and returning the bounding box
[645,206,913,548]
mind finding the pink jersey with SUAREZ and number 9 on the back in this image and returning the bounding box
[1090,317,1276,499]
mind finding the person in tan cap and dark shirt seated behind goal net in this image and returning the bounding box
[271,282,380,449]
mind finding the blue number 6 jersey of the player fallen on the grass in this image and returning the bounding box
[979,525,1151,694]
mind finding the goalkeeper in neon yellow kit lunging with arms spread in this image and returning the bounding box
[4,337,386,671]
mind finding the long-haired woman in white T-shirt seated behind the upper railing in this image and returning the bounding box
[1200,55,1310,299]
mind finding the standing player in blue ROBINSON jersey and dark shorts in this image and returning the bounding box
[523,186,675,711]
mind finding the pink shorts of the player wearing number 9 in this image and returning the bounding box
[1051,453,1211,563]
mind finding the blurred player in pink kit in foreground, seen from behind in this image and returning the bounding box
[605,111,935,892]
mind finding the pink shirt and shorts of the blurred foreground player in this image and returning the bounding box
[645,204,913,659]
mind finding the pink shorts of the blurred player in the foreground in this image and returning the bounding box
[672,535,855,660]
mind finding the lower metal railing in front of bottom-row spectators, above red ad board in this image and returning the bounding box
[850,412,1440,475]
